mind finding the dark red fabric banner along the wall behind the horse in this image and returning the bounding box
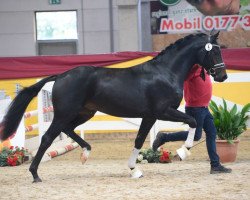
[0,48,250,79]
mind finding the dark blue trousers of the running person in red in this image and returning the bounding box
[163,107,220,167]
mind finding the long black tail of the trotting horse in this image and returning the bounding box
[0,76,56,140]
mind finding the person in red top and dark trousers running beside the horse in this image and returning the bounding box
[153,65,232,174]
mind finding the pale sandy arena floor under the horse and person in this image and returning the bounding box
[0,131,250,200]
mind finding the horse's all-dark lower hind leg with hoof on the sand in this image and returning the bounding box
[29,122,61,183]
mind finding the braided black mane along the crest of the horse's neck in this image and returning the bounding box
[153,33,206,60]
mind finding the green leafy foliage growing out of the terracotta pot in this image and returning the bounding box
[209,99,250,143]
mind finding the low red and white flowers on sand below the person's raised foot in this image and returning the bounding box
[136,147,173,164]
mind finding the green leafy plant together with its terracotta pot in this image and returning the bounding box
[209,99,250,163]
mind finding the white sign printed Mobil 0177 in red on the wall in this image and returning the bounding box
[151,1,250,34]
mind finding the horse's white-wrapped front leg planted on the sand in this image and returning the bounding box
[128,118,156,178]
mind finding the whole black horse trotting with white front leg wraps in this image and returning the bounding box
[0,33,227,182]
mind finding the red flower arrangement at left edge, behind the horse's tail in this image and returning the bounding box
[0,146,27,167]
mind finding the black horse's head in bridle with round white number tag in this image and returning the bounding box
[198,32,227,82]
